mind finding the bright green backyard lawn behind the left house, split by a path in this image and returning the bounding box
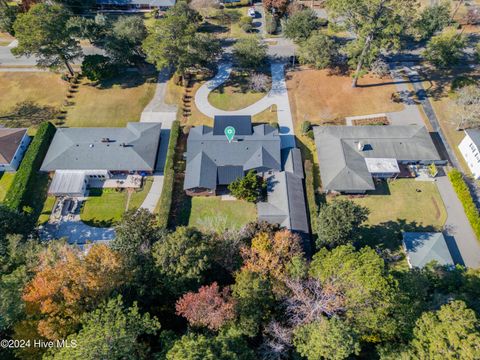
[80,179,152,227]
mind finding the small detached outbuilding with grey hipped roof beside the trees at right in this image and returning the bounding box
[402,232,455,268]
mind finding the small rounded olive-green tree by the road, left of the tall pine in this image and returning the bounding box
[298,32,339,69]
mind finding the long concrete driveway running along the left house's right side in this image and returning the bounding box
[140,69,177,212]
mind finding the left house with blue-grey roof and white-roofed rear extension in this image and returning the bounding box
[40,123,161,196]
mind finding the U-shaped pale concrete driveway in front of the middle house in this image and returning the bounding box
[195,62,295,148]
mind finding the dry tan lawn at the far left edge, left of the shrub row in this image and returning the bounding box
[0,72,68,115]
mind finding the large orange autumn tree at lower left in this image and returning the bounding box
[23,245,128,340]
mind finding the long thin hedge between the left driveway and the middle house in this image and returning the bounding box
[158,120,180,229]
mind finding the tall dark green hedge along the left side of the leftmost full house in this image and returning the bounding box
[4,122,56,211]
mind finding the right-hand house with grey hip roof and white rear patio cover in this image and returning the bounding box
[314,125,446,193]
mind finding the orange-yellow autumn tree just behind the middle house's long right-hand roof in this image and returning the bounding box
[242,230,305,293]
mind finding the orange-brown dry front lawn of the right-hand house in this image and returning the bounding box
[287,68,403,124]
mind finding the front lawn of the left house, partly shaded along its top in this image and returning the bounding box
[65,73,155,127]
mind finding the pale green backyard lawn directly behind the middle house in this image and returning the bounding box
[188,196,257,231]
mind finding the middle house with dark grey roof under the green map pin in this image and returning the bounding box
[183,116,281,196]
